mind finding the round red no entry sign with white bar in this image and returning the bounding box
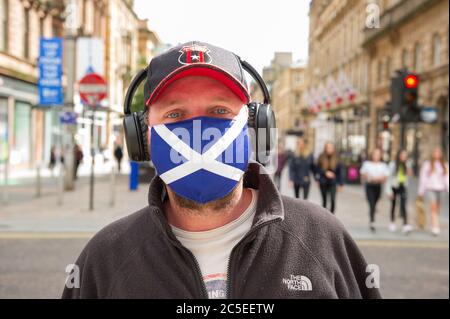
[79,73,108,106]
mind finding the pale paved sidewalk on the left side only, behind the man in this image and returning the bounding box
[0,175,148,232]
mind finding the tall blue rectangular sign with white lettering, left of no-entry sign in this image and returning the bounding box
[38,38,64,106]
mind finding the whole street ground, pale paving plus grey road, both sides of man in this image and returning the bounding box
[0,165,449,298]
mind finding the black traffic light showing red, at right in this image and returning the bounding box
[391,70,420,123]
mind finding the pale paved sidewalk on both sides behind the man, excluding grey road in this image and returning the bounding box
[0,165,449,242]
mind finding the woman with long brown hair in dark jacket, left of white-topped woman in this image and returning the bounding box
[314,142,344,214]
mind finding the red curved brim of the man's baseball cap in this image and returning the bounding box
[145,63,250,106]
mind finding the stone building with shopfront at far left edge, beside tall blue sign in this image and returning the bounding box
[0,0,63,169]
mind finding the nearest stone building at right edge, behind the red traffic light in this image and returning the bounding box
[364,0,449,166]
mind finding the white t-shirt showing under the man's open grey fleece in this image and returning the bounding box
[171,189,258,299]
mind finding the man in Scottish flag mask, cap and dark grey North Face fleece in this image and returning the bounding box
[63,42,380,298]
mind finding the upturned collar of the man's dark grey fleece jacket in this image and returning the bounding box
[148,162,284,235]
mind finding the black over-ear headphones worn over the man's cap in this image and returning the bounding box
[123,59,276,165]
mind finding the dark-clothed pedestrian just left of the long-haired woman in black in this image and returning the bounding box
[289,138,314,199]
